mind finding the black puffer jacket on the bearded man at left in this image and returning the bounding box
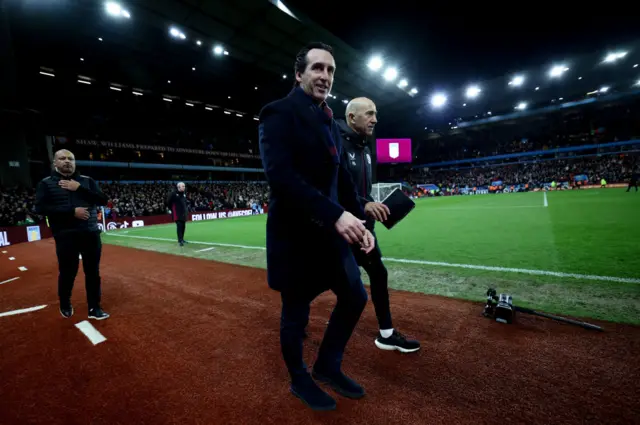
[35,171,107,236]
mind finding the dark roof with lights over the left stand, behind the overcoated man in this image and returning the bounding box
[9,0,410,124]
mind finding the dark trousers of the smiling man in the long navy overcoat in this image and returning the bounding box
[280,272,367,384]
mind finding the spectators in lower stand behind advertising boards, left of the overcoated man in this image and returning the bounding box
[0,182,269,227]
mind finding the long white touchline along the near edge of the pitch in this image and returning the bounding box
[107,233,640,283]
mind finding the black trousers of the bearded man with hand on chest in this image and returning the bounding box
[55,232,102,309]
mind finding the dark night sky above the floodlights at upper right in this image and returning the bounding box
[284,0,640,89]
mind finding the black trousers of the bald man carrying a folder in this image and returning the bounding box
[351,231,393,329]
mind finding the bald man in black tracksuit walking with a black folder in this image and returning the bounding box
[338,98,420,353]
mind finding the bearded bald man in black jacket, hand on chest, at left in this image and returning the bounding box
[36,150,109,320]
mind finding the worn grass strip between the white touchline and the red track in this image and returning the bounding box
[102,236,640,325]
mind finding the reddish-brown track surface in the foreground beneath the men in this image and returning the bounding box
[0,240,640,425]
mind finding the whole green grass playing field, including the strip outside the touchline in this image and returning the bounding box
[103,188,640,324]
